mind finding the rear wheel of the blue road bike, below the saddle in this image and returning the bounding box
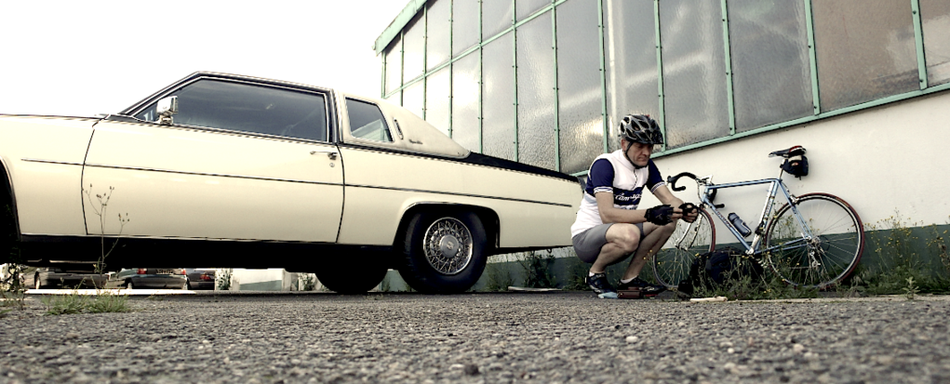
[764,193,864,289]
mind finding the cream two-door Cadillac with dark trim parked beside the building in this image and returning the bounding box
[0,72,580,293]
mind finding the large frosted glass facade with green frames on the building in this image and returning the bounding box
[377,0,950,174]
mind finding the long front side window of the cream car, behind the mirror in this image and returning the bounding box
[135,80,327,141]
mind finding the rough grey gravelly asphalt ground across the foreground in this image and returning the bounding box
[0,292,950,383]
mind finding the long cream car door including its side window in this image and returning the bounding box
[82,78,343,242]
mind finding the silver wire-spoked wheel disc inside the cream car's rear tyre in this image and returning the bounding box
[423,217,474,275]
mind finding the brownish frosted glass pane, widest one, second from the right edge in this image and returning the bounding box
[812,0,920,111]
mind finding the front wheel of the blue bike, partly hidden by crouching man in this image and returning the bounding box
[653,208,716,288]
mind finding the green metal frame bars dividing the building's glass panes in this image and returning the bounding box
[373,0,950,176]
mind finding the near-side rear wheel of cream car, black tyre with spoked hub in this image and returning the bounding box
[399,211,487,293]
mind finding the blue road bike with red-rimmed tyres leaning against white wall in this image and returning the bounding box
[653,146,864,289]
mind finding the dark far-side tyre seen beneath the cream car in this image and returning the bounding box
[315,252,389,294]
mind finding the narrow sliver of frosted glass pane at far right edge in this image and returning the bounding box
[920,0,950,86]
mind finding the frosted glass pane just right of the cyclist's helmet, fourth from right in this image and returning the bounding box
[660,0,729,148]
